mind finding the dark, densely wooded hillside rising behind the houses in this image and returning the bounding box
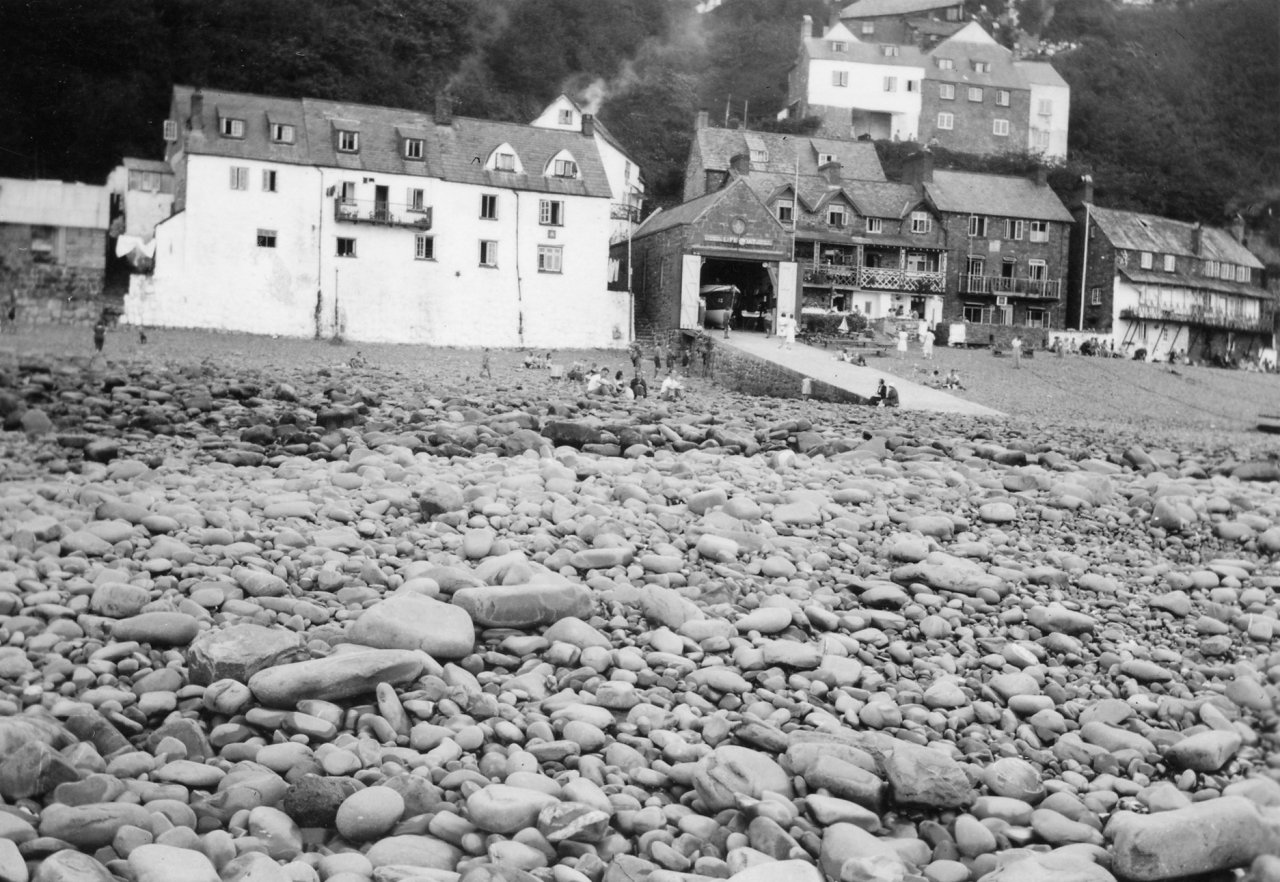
[0,0,1280,234]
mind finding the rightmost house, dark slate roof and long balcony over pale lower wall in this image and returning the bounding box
[1068,197,1275,364]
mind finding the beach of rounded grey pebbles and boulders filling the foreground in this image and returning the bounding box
[0,357,1280,882]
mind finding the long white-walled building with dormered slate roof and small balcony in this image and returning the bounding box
[135,86,630,348]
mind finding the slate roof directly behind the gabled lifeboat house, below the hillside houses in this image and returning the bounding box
[692,127,884,184]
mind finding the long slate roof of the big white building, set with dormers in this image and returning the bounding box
[172,86,611,198]
